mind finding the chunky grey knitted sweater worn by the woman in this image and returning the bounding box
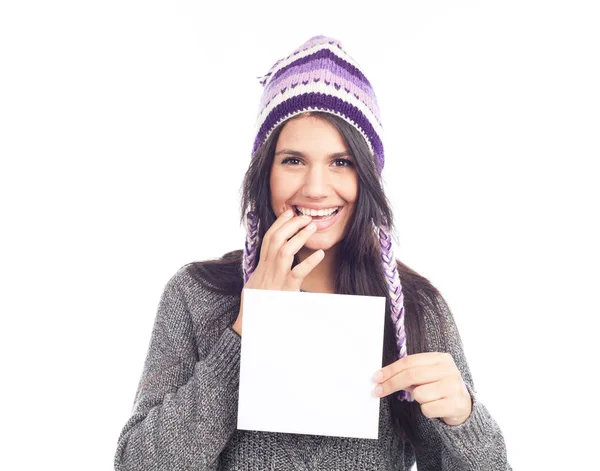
[115,265,512,471]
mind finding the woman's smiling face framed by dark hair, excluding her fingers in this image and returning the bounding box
[270,116,358,251]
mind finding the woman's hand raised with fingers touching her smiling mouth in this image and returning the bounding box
[232,209,325,335]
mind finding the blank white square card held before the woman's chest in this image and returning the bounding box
[237,289,385,439]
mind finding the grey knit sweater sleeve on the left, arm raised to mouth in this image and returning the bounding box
[114,269,241,471]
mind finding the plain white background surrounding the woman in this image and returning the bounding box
[0,0,600,470]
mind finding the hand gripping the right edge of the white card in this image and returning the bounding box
[373,352,473,425]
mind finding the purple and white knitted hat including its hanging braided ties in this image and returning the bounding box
[243,36,412,401]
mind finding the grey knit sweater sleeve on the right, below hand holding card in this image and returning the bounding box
[415,295,512,471]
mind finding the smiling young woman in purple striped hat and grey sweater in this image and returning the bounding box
[115,36,511,471]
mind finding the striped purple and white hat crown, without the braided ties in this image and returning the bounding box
[252,36,384,175]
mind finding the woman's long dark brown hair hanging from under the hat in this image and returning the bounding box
[189,111,444,450]
